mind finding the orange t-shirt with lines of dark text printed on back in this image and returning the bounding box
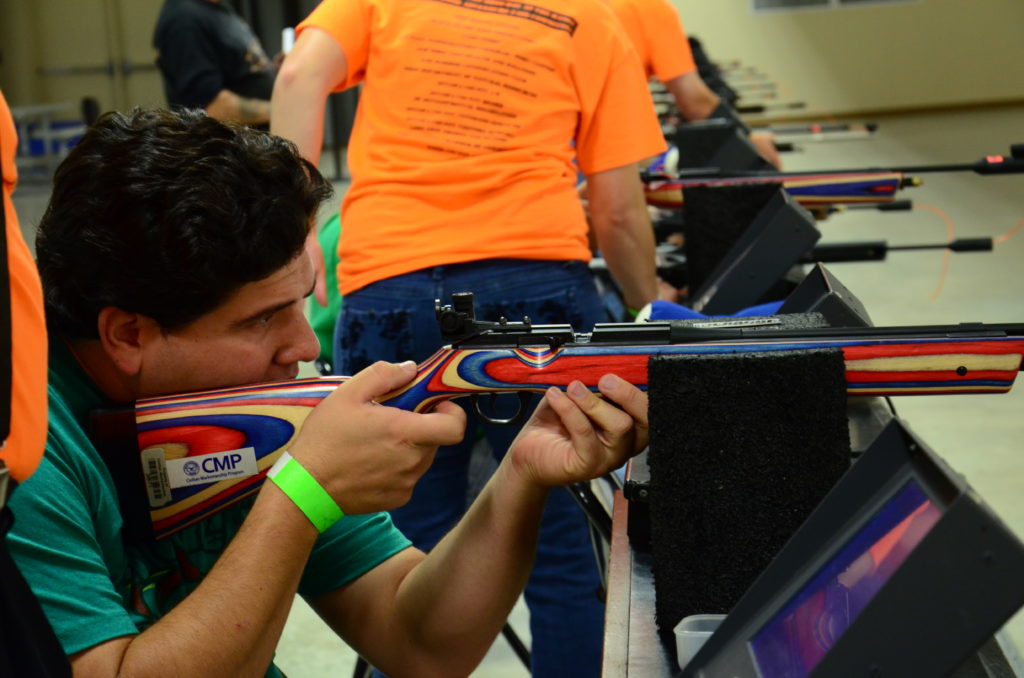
[299,0,665,294]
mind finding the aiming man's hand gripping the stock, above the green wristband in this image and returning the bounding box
[291,363,466,514]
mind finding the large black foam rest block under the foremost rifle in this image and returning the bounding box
[648,349,850,642]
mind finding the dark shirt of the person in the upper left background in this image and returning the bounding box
[153,0,274,109]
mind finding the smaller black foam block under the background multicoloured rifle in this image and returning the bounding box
[682,183,781,298]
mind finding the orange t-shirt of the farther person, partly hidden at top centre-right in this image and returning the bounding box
[605,0,697,82]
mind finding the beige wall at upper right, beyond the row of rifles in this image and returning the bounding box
[673,0,1024,115]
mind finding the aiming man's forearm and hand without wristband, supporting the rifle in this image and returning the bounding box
[364,375,647,678]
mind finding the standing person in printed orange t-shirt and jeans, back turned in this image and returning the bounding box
[270,0,665,677]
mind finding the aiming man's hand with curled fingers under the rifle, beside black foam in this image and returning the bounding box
[509,374,647,486]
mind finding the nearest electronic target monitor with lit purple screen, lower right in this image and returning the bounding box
[677,419,1024,678]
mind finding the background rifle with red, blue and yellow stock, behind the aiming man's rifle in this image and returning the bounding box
[640,143,1024,209]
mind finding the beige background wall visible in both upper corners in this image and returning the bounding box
[0,0,1024,116]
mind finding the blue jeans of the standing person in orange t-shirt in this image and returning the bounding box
[334,259,607,678]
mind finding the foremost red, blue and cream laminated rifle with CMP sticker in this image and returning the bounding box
[93,293,1024,539]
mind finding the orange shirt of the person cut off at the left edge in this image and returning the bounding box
[0,92,46,481]
